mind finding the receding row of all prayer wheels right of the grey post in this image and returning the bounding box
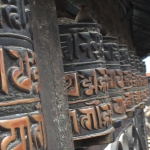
[59,23,149,144]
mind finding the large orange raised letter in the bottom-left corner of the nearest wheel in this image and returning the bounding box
[0,117,33,150]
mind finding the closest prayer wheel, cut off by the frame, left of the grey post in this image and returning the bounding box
[0,0,47,150]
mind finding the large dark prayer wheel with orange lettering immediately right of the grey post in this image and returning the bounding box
[59,23,114,144]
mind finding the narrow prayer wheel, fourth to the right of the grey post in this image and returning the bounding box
[129,51,141,108]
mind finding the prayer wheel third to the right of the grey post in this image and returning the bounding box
[119,45,135,117]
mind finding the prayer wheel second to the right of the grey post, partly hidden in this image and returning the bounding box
[103,36,127,121]
